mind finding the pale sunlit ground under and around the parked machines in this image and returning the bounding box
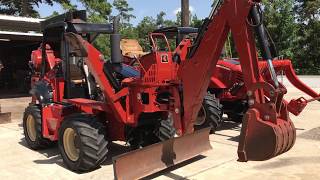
[0,77,320,180]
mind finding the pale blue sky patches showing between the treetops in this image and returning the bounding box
[36,0,212,25]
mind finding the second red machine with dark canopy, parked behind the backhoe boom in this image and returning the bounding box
[154,27,320,124]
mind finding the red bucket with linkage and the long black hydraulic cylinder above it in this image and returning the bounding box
[238,4,296,162]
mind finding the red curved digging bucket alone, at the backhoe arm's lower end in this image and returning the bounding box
[238,108,296,162]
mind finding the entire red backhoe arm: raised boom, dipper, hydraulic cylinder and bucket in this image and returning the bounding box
[178,0,296,162]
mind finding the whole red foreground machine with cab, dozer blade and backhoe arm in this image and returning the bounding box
[23,0,310,179]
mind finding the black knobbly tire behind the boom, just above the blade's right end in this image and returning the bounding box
[194,92,223,133]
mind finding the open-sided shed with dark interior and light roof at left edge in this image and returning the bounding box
[0,15,43,98]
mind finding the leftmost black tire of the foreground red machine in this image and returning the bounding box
[23,105,54,150]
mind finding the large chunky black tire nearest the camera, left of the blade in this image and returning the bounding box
[58,114,108,172]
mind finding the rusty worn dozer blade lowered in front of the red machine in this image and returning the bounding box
[113,128,211,180]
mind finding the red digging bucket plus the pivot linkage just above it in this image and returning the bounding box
[238,83,296,162]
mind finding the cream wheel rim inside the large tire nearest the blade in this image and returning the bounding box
[63,128,80,161]
